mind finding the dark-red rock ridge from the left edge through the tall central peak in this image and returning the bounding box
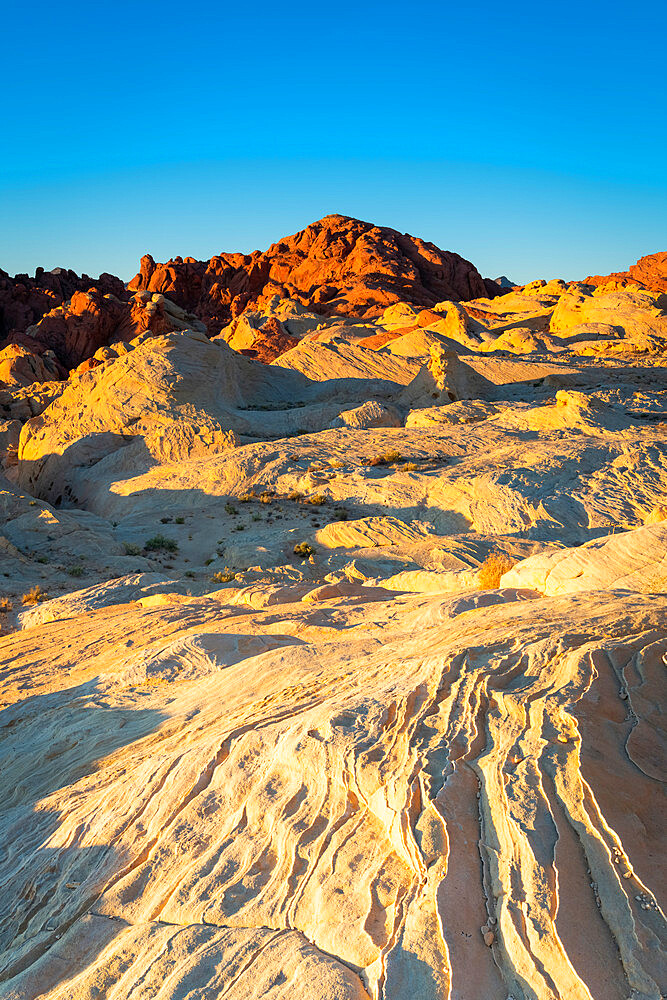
[0,215,501,367]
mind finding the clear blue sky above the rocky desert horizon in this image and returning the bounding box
[0,0,667,281]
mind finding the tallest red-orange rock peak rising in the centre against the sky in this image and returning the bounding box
[128,215,494,335]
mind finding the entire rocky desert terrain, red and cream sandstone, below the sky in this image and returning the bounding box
[0,216,667,1000]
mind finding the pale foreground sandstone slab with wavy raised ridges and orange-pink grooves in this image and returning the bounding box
[0,591,667,1000]
